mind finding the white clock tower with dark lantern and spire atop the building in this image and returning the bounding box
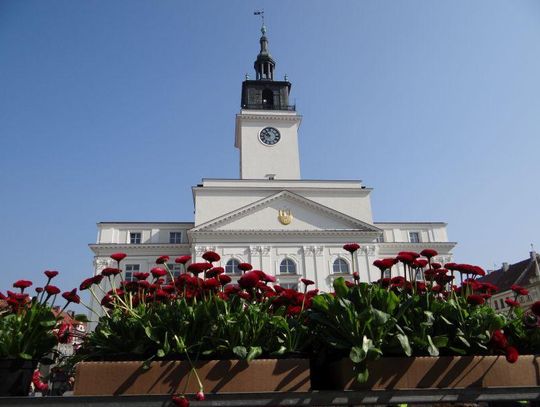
[235,25,302,180]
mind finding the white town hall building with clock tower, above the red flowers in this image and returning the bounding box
[90,26,455,300]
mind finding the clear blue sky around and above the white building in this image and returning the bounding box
[0,0,540,302]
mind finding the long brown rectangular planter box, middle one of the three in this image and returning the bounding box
[74,359,310,396]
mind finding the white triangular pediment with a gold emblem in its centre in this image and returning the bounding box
[192,191,380,232]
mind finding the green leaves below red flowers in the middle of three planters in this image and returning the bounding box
[78,295,309,361]
